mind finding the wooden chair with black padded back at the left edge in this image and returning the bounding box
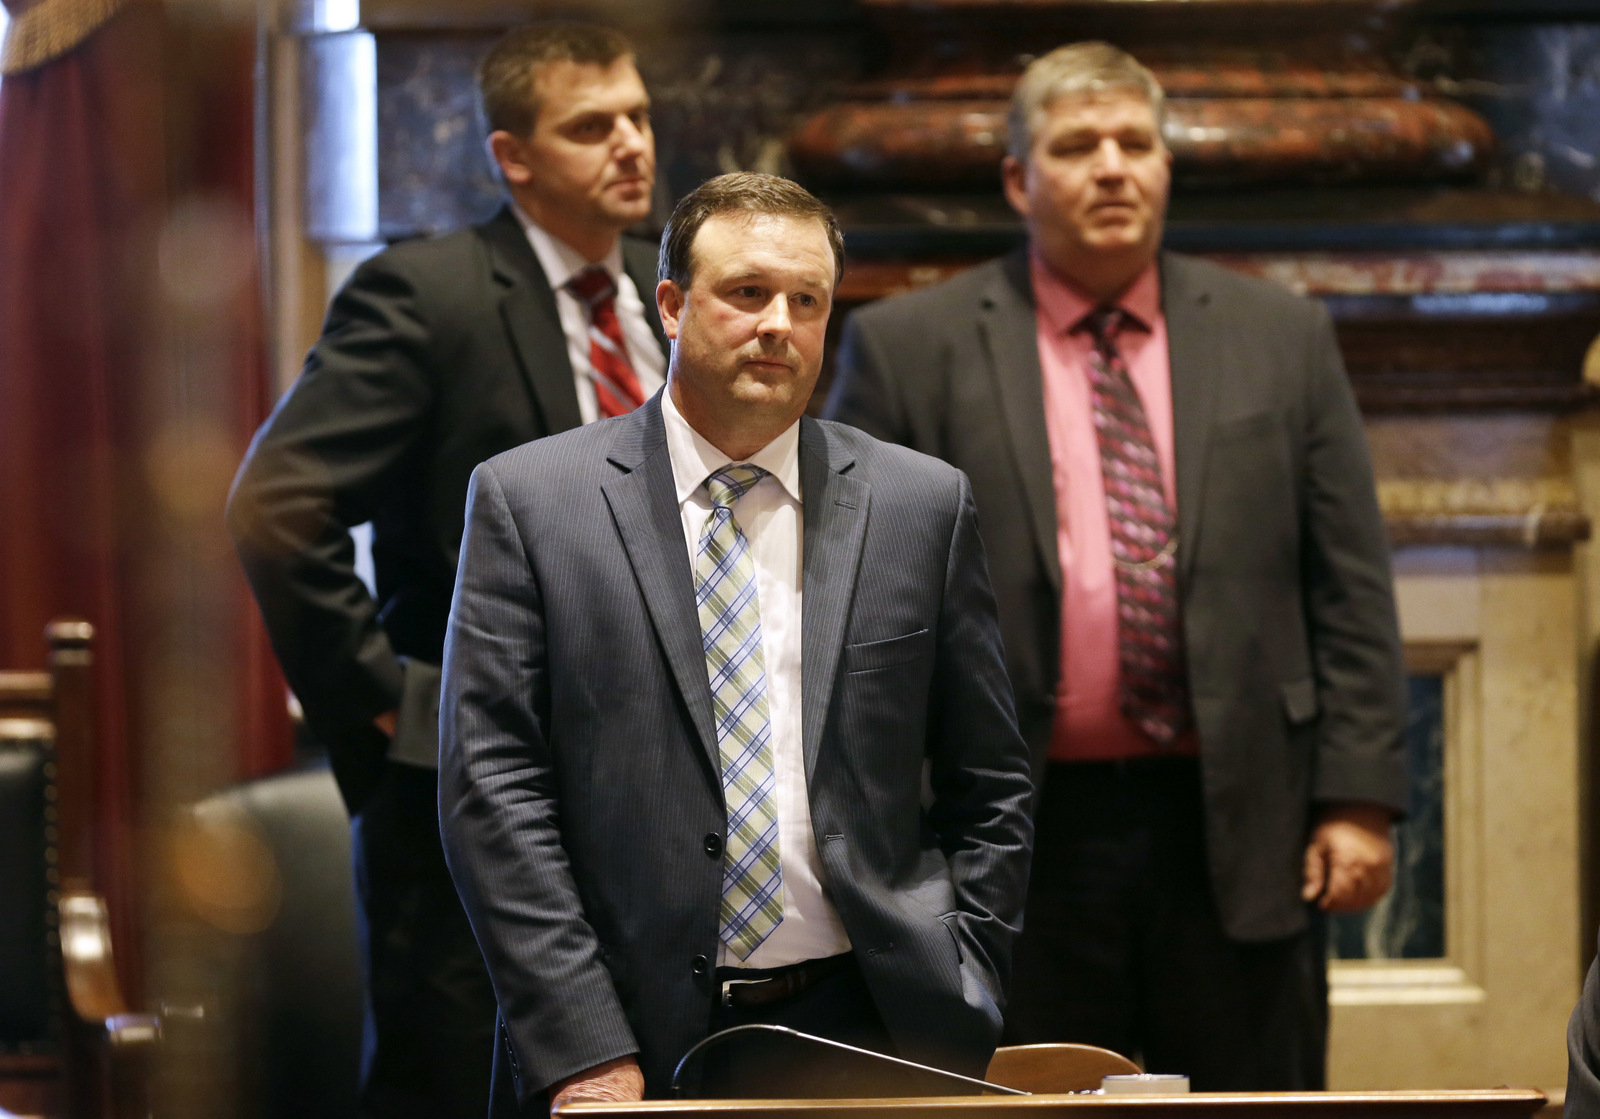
[0,620,158,1119]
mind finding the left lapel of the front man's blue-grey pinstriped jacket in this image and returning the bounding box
[602,394,722,774]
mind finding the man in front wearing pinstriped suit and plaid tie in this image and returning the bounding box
[440,174,1032,1116]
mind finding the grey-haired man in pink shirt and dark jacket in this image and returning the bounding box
[830,43,1406,1090]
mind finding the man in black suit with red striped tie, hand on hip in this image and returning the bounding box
[229,22,666,1119]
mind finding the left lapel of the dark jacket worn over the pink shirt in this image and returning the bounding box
[978,250,1061,594]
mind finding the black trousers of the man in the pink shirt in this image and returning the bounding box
[1006,757,1328,1092]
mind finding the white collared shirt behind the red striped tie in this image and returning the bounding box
[512,205,667,424]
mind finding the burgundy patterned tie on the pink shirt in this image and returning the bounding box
[1075,307,1189,746]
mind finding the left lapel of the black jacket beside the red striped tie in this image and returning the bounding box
[482,207,582,434]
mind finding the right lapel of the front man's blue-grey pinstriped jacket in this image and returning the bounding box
[800,418,870,781]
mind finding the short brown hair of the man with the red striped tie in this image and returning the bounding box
[478,19,635,136]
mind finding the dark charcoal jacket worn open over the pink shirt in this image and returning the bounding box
[829,251,1406,940]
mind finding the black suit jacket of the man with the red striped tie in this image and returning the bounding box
[227,208,666,808]
